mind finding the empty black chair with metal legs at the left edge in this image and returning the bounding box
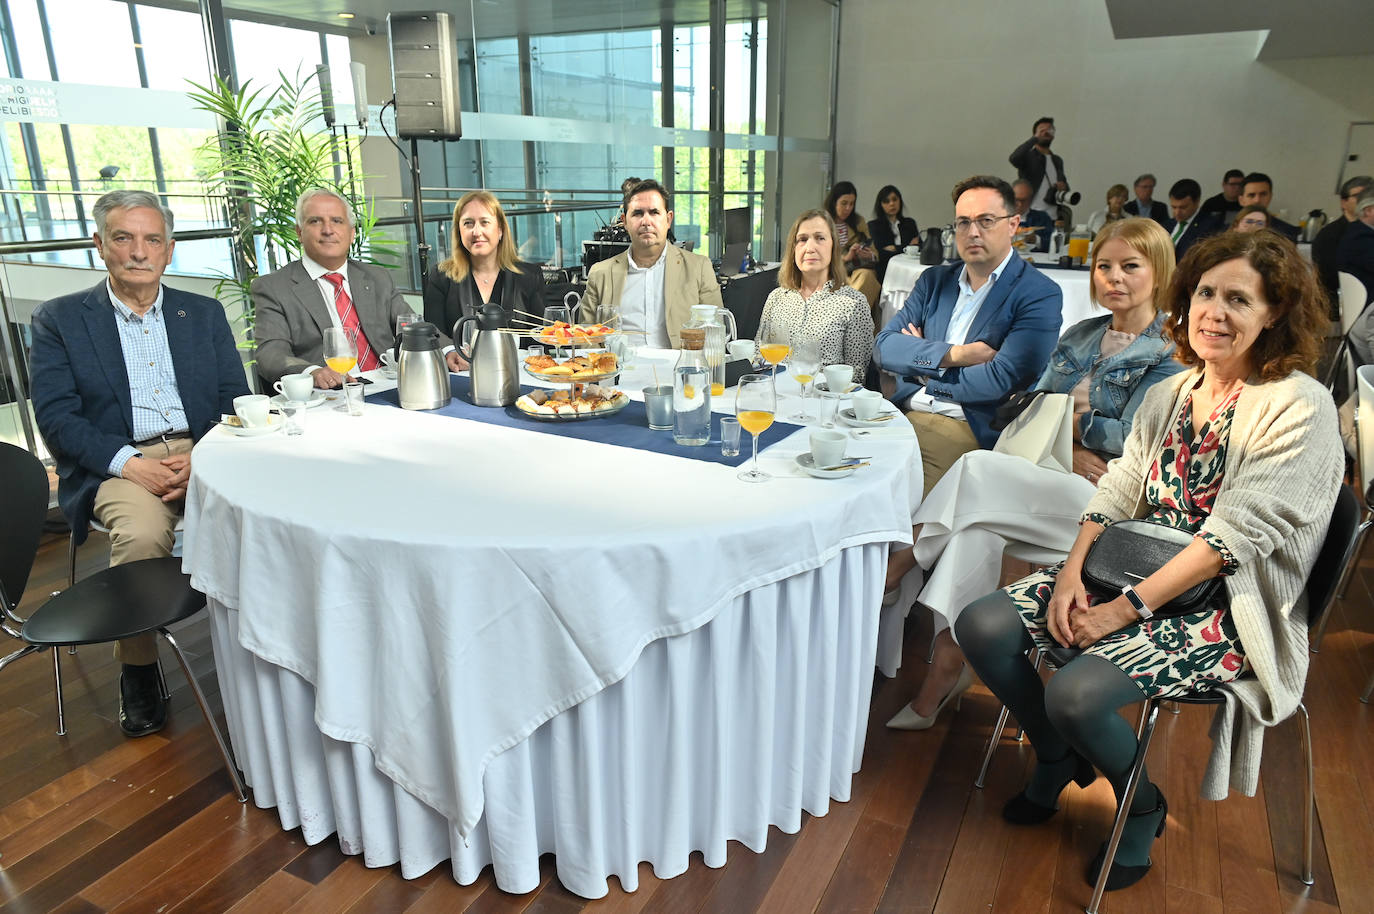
[0,444,247,803]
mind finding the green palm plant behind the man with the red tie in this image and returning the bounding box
[188,73,394,348]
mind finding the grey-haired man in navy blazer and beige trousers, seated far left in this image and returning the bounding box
[30,190,249,737]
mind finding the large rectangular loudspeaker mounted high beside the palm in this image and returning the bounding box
[386,12,463,140]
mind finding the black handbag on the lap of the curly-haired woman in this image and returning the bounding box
[1083,521,1226,618]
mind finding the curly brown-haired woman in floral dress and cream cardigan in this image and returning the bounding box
[955,232,1344,889]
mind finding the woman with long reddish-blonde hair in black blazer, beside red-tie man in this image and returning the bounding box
[425,191,544,350]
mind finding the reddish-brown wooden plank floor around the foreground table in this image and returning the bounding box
[0,519,1374,914]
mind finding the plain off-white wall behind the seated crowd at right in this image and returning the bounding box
[835,0,1374,235]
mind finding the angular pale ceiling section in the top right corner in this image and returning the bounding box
[1106,0,1374,60]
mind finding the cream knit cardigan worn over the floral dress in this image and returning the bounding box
[1087,368,1345,800]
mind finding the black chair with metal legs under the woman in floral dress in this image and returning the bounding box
[1087,485,1360,914]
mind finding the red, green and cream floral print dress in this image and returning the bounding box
[1003,389,1245,698]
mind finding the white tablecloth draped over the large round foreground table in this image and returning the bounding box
[184,368,921,898]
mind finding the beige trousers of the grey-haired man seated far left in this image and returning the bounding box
[92,438,194,665]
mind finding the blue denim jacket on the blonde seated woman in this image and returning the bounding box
[1033,312,1183,458]
